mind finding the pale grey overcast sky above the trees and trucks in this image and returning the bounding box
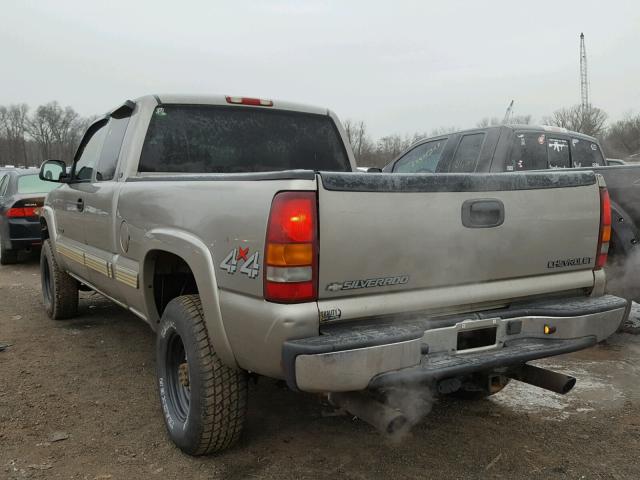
[0,0,640,137]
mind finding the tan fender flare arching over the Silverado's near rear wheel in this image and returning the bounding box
[140,228,239,368]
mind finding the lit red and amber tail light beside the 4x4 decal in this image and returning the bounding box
[264,192,318,303]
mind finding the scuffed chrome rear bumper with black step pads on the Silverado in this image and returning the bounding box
[283,295,629,392]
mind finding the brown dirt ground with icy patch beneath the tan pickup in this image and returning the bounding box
[0,255,640,480]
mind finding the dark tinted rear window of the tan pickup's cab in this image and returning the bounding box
[138,105,351,173]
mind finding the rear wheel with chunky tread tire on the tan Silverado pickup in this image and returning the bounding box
[156,295,247,456]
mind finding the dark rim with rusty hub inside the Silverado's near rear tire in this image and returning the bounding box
[166,332,191,423]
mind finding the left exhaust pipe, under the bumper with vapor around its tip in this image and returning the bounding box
[329,392,409,435]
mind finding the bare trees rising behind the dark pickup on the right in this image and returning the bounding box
[344,105,640,167]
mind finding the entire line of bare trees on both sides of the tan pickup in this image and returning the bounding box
[0,101,640,167]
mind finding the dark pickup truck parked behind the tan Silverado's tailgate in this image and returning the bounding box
[383,125,640,300]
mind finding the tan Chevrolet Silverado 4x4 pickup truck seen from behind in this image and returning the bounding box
[40,95,628,455]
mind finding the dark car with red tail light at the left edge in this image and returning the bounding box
[0,170,58,265]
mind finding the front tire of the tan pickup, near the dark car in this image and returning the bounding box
[40,239,78,320]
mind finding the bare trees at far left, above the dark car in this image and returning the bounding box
[0,102,93,167]
